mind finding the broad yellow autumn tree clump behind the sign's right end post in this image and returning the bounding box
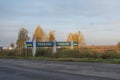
[67,31,85,47]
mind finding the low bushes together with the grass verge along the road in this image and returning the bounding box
[0,48,120,63]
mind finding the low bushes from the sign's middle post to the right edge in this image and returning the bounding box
[54,49,120,59]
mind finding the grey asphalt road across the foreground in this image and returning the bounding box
[0,59,120,80]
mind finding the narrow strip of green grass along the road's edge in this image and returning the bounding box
[0,56,120,64]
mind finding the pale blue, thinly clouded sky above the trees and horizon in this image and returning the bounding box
[0,0,120,46]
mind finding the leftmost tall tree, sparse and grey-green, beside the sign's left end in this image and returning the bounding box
[16,28,29,55]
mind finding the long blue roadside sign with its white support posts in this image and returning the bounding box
[26,39,78,56]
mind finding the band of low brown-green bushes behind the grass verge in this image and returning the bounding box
[0,48,120,59]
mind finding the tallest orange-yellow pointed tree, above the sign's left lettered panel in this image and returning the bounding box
[33,26,47,41]
